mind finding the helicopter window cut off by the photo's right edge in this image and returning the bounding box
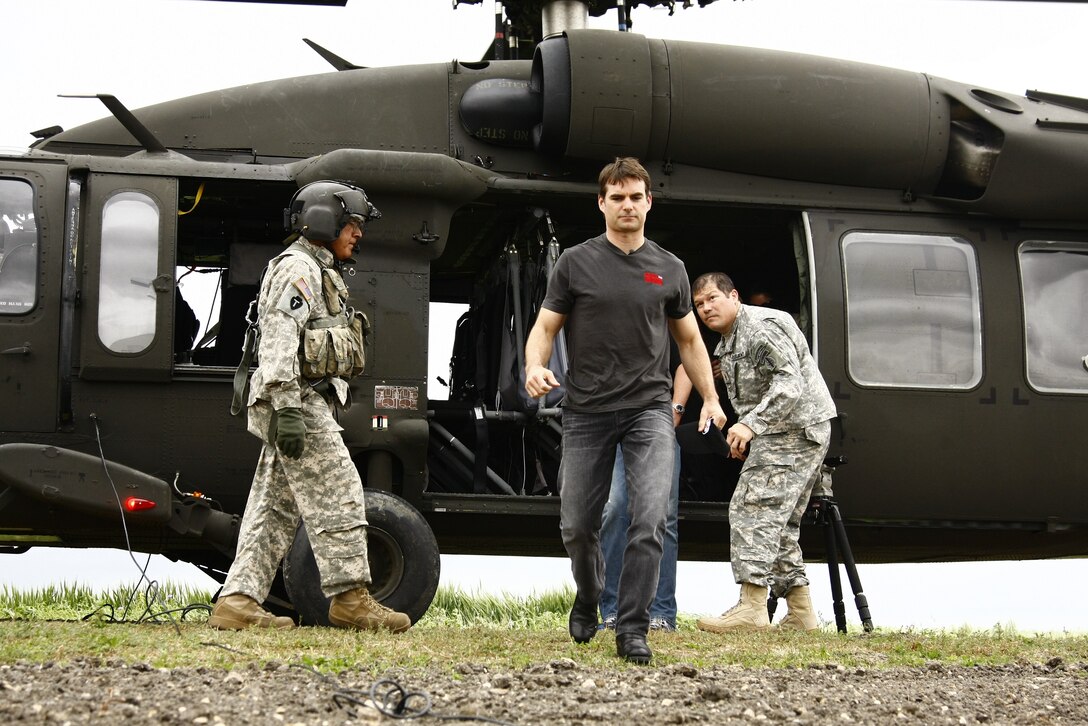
[1019,241,1088,393]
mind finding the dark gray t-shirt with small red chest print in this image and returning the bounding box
[543,235,692,413]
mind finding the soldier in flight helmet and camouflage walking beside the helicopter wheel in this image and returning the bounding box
[208,182,411,632]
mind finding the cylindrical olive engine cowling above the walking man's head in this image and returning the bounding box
[530,30,949,192]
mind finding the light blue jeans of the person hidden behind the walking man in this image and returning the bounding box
[601,443,680,628]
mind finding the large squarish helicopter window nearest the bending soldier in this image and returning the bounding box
[842,232,982,389]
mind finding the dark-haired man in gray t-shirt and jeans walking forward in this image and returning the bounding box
[526,158,726,663]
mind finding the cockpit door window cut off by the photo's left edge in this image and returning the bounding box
[0,179,38,316]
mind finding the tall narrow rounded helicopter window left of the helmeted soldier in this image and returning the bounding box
[98,192,159,354]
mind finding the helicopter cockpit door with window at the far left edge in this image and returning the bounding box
[0,160,69,432]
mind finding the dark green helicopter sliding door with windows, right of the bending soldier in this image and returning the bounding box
[806,206,1088,554]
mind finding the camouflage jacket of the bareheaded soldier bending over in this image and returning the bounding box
[714,305,836,435]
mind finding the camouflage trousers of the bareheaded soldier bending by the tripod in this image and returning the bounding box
[729,421,831,598]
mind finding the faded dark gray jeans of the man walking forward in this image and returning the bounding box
[559,403,676,635]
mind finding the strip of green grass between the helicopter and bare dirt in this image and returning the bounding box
[0,585,1088,677]
